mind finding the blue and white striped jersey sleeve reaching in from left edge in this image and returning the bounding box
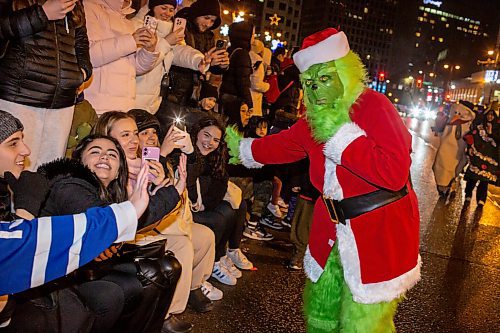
[0,201,137,295]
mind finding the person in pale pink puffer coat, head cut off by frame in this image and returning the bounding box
[84,0,159,115]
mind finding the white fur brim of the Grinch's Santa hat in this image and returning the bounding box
[293,31,350,73]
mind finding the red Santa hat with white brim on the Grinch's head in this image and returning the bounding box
[293,28,350,73]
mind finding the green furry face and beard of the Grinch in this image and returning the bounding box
[300,51,366,142]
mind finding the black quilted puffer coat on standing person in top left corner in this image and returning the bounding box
[0,0,92,109]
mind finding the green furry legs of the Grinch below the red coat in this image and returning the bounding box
[304,245,401,333]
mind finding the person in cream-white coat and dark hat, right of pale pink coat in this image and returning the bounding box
[132,0,205,114]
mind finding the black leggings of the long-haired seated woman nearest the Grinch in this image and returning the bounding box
[193,200,247,262]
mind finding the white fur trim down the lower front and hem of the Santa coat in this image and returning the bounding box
[337,220,422,304]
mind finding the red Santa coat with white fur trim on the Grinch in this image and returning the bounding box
[240,89,421,304]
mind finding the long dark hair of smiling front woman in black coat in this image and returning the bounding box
[72,134,128,203]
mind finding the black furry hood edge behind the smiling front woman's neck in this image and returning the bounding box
[37,158,101,188]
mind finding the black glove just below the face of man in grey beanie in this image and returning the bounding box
[4,171,50,216]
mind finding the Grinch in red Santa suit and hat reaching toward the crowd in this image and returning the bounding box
[227,28,421,332]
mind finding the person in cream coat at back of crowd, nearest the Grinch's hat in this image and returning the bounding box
[250,39,269,116]
